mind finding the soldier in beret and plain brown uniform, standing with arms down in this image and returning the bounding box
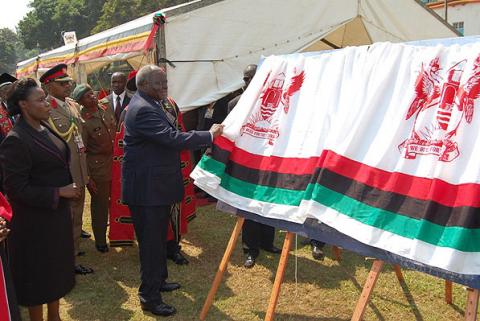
[72,84,116,253]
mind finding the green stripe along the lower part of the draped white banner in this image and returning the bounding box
[199,156,480,252]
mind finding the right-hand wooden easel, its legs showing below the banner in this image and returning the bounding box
[351,260,479,321]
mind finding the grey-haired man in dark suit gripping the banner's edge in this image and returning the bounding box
[122,65,223,316]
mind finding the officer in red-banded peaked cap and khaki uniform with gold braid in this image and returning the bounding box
[40,64,93,274]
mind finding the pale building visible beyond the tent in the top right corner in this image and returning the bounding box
[421,0,480,36]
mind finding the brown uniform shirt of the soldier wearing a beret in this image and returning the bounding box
[81,103,116,182]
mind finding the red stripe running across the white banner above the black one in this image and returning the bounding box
[215,136,480,207]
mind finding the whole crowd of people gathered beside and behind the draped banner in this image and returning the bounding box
[0,64,323,321]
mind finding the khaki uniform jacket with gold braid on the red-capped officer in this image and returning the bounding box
[47,96,89,187]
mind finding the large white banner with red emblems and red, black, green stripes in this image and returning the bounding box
[192,43,480,275]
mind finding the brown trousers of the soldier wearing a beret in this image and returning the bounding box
[90,181,112,245]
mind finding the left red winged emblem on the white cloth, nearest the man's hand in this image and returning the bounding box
[240,70,305,144]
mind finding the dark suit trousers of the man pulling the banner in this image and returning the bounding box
[128,205,171,303]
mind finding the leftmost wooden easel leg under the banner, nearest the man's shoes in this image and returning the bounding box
[200,216,245,321]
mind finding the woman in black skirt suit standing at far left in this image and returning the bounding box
[0,78,79,321]
